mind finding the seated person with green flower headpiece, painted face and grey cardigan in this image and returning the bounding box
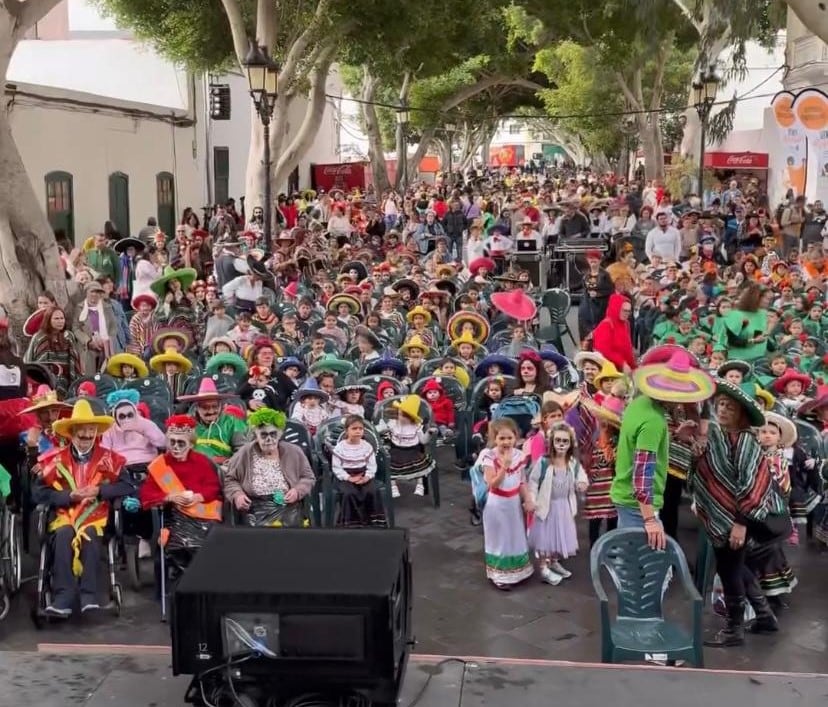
[224,407,316,528]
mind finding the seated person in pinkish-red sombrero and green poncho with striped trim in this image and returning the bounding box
[178,377,247,465]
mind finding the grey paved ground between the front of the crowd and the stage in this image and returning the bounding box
[0,460,828,676]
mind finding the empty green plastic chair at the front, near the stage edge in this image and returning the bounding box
[589,528,704,668]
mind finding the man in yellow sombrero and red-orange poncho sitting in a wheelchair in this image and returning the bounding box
[34,399,134,618]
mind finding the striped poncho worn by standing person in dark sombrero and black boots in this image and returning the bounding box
[689,421,785,547]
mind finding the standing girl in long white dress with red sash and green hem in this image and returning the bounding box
[477,418,533,590]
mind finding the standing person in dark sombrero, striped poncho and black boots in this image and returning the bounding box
[689,379,792,648]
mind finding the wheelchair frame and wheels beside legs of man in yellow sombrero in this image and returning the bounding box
[31,499,123,629]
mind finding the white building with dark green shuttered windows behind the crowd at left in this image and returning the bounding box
[6,0,341,244]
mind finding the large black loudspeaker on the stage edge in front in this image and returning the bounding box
[170,526,411,705]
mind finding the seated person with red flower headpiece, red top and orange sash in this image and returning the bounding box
[139,415,222,578]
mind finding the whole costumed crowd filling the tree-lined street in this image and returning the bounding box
[0,169,828,660]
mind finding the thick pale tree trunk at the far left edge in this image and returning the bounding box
[0,9,69,330]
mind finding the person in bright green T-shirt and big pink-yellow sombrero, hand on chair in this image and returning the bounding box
[610,350,715,550]
